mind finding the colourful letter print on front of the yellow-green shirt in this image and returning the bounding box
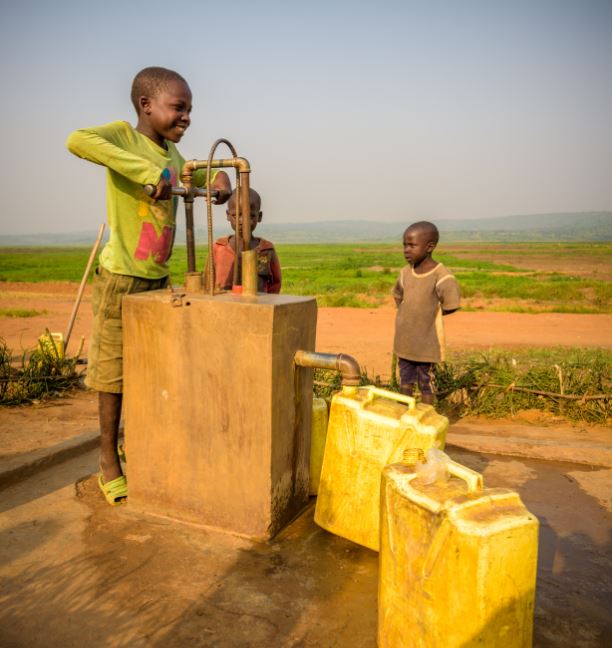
[134,167,177,263]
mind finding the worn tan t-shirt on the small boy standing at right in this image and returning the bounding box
[393,263,461,362]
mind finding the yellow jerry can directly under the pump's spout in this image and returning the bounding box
[315,385,448,551]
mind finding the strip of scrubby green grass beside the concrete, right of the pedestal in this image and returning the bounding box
[315,348,612,425]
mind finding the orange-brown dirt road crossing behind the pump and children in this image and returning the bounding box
[0,282,612,376]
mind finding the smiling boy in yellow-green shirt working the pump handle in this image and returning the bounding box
[66,67,231,504]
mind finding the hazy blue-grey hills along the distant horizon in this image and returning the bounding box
[0,211,612,247]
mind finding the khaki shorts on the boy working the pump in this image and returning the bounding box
[85,267,168,394]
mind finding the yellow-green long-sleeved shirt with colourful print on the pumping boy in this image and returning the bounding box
[66,121,216,279]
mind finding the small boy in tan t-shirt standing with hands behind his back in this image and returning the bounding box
[393,221,461,405]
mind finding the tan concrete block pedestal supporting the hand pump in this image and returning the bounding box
[123,291,317,539]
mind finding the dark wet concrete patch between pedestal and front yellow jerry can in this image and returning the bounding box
[148,508,378,648]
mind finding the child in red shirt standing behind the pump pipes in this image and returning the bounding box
[213,189,281,293]
